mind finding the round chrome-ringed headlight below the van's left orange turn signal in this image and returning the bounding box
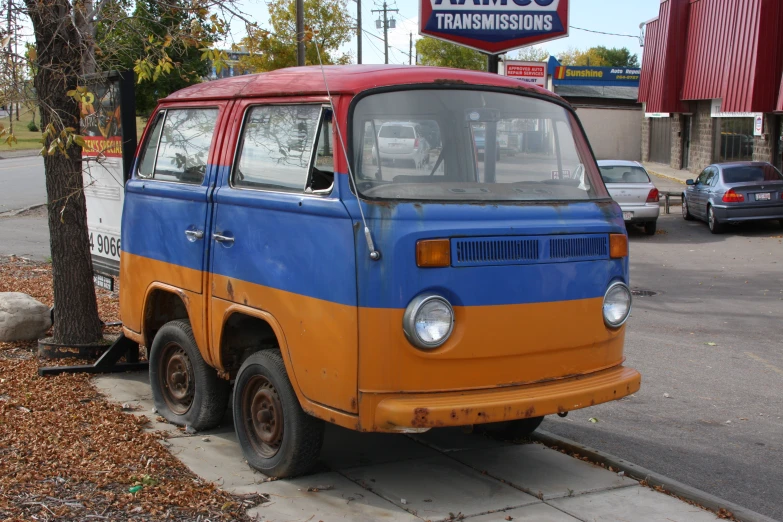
[402,294,454,350]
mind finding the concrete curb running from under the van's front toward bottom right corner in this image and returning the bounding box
[531,430,778,522]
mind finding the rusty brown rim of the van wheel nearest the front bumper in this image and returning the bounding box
[242,375,283,459]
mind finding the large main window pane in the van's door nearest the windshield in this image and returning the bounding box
[232,105,321,192]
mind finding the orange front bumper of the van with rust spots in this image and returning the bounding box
[369,366,642,431]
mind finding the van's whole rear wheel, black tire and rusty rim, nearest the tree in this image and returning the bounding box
[149,320,231,431]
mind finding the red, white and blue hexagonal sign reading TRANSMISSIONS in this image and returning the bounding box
[419,0,568,54]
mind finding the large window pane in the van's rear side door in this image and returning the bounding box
[152,109,218,185]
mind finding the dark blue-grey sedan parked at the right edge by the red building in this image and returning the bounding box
[682,161,783,234]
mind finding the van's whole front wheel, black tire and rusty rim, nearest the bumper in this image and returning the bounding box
[233,350,324,478]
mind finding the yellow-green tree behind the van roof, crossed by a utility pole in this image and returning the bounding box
[237,0,354,72]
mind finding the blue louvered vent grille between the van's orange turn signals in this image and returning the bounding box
[451,234,609,267]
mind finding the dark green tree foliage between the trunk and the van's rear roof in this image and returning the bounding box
[96,0,222,116]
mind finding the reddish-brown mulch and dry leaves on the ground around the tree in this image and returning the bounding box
[0,260,255,521]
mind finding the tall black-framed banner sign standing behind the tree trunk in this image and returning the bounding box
[80,72,136,280]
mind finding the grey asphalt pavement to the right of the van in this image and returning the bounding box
[542,210,783,520]
